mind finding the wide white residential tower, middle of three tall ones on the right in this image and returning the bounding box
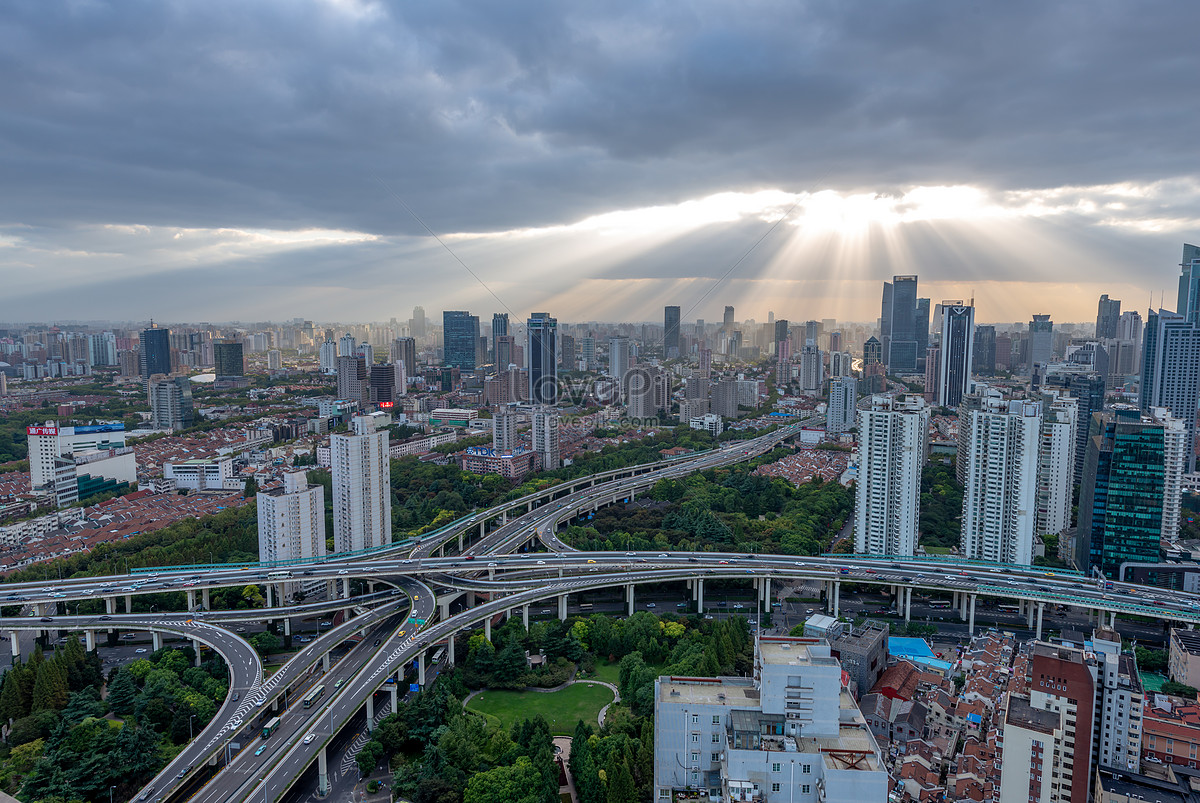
[960,397,1042,565]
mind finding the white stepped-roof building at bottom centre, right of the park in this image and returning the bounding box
[650,636,888,803]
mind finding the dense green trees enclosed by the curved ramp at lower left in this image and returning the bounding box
[0,637,228,801]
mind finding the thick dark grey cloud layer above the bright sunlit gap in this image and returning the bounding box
[0,0,1200,237]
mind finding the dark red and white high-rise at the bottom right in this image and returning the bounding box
[998,642,1096,803]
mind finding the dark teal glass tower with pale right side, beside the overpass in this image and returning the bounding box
[1075,408,1188,580]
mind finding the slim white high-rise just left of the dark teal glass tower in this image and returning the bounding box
[1037,391,1079,535]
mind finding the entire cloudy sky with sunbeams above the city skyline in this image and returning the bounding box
[0,0,1200,322]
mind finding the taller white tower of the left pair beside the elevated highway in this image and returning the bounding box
[329,413,391,552]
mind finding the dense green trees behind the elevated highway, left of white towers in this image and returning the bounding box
[564,465,853,555]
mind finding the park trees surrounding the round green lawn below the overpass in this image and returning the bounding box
[360,612,752,803]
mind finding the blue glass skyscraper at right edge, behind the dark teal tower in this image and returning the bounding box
[1139,307,1200,473]
